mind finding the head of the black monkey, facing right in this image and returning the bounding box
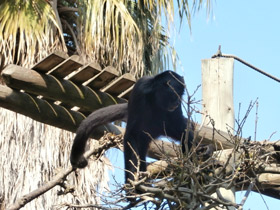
[154,71,185,112]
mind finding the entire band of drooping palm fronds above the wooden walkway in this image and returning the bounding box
[0,0,210,77]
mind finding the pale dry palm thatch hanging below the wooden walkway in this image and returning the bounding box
[0,109,110,209]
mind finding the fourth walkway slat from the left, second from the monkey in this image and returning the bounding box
[84,66,119,90]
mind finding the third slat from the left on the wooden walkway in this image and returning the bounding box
[68,63,101,84]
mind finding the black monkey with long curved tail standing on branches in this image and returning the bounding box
[70,71,193,183]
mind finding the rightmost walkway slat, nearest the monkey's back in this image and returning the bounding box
[101,73,135,95]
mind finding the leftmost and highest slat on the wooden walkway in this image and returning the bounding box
[32,51,68,73]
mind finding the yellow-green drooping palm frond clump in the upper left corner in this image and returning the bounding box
[0,0,66,69]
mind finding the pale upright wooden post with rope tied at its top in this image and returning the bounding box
[202,58,235,210]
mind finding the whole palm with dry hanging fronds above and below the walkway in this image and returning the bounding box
[0,0,210,209]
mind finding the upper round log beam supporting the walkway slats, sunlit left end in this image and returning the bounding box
[2,64,126,112]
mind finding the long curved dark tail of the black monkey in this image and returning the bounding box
[70,103,127,168]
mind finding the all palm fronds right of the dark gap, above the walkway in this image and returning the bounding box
[68,0,212,77]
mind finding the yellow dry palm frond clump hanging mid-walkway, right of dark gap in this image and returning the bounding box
[77,0,144,75]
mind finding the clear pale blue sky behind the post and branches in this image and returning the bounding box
[109,0,280,210]
